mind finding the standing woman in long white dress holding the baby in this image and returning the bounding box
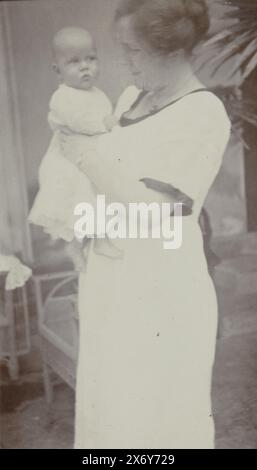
[64,0,230,449]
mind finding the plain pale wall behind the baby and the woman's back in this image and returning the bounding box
[6,0,246,235]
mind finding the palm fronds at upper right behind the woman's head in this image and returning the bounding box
[205,0,257,129]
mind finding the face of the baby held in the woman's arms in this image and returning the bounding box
[56,36,99,90]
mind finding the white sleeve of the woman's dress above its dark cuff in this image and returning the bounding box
[141,97,231,201]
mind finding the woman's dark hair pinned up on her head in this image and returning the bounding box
[116,0,210,54]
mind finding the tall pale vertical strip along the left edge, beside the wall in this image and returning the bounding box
[0,4,32,261]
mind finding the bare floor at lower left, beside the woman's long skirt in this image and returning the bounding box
[0,374,74,449]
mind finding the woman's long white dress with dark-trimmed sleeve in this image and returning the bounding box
[75,89,230,449]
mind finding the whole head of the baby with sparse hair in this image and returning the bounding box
[53,27,99,90]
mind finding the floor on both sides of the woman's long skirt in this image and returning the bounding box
[0,235,257,449]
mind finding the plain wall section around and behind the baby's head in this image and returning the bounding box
[7,0,126,200]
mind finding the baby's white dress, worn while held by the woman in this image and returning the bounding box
[29,84,112,242]
